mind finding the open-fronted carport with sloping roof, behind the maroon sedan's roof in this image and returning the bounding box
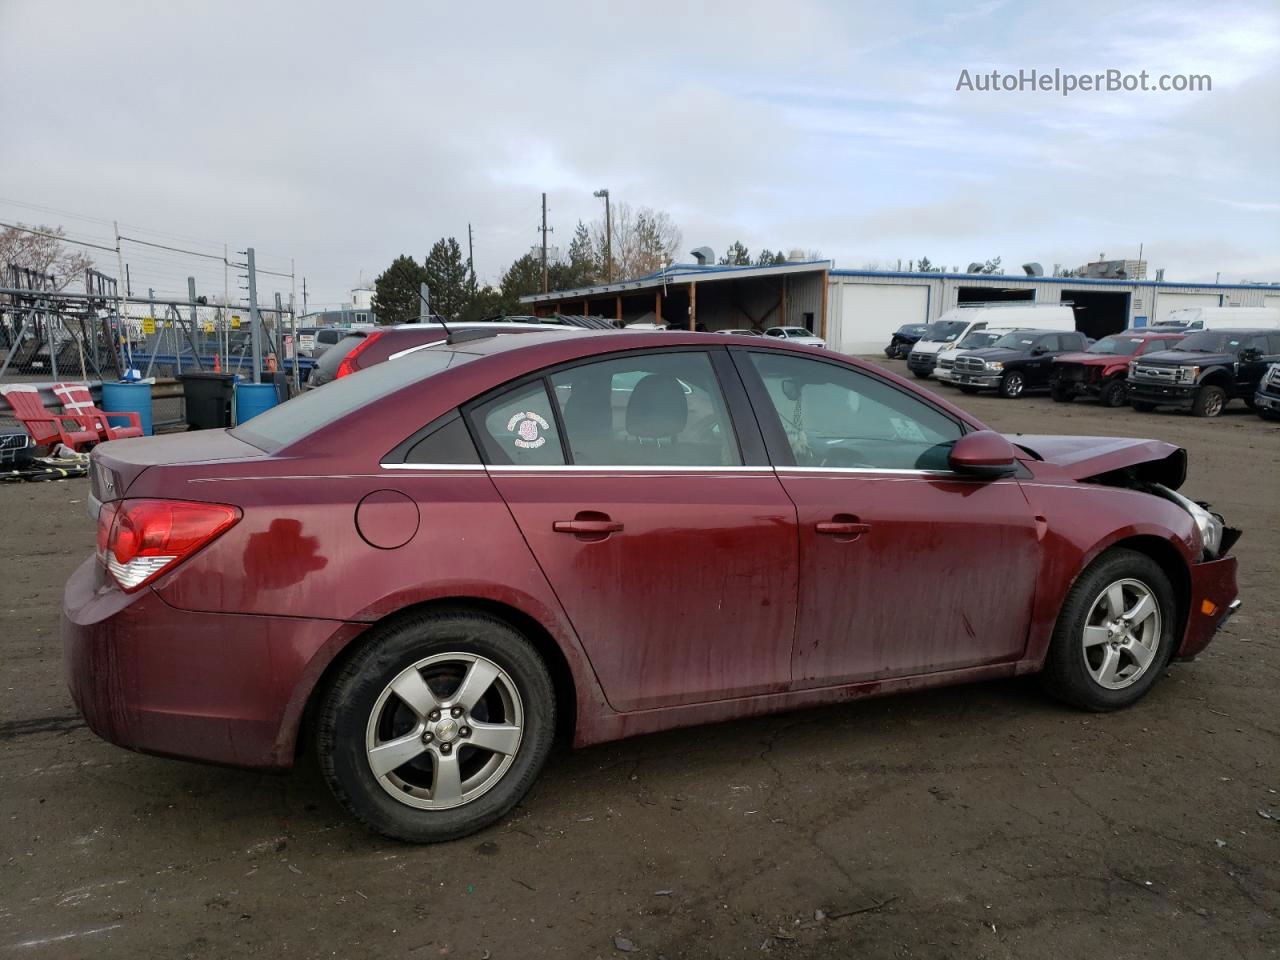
[520,260,832,337]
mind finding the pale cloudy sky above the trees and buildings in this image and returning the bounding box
[0,0,1280,303]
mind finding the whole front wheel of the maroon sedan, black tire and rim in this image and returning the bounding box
[1041,548,1176,712]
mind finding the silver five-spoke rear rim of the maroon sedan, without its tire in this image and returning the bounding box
[365,652,524,810]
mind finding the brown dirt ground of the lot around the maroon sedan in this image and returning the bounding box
[0,364,1280,960]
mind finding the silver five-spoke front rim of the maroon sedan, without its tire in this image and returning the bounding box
[1080,580,1161,690]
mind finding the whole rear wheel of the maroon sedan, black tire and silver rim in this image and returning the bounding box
[315,609,556,844]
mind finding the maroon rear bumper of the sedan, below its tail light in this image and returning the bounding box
[61,557,365,768]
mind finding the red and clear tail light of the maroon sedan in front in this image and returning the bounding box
[97,499,241,593]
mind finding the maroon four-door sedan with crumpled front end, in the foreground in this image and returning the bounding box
[63,333,1238,841]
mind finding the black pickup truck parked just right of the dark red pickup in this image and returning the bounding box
[1129,329,1280,417]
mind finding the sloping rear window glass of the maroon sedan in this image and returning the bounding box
[230,344,476,453]
